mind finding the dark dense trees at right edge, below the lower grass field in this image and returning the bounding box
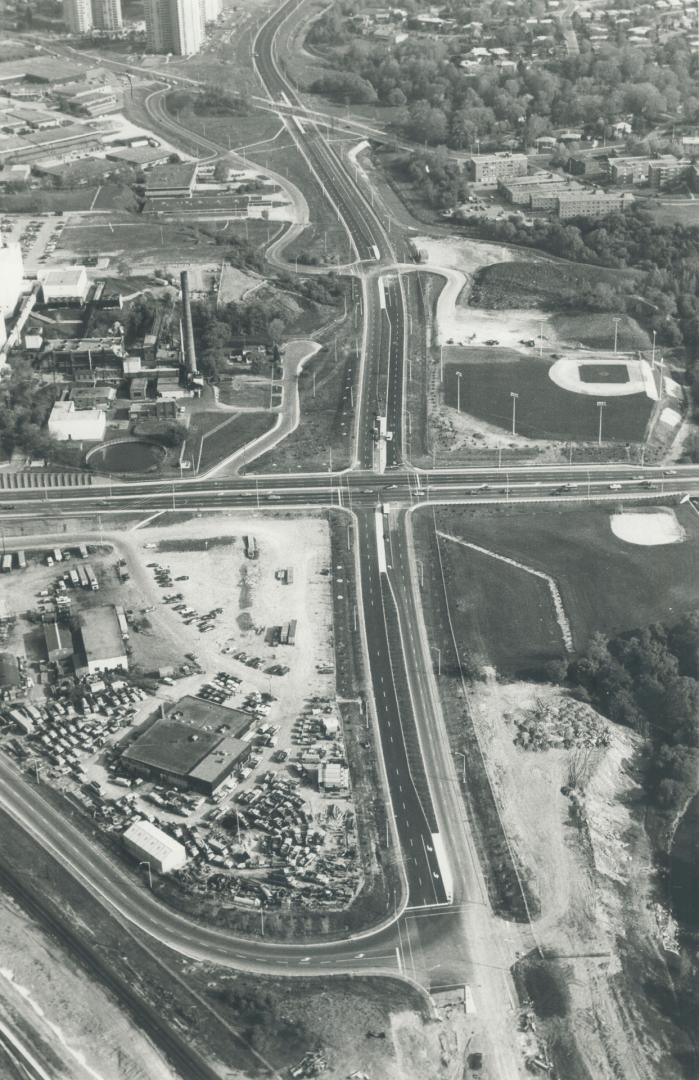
[550,612,699,814]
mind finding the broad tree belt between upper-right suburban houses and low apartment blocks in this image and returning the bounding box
[309,20,699,149]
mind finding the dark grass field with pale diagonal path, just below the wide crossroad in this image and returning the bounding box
[435,507,699,674]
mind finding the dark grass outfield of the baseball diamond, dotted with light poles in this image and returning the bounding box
[444,349,653,443]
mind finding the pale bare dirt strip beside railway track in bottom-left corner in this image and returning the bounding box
[0,894,175,1080]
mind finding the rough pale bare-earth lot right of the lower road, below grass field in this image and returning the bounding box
[471,678,676,1080]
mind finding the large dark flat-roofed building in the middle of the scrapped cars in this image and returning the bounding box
[121,697,251,795]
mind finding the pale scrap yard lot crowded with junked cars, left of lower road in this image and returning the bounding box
[1,518,361,909]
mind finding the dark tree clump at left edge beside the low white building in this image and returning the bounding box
[0,360,55,457]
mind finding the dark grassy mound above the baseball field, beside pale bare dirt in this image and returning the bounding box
[469,258,638,310]
